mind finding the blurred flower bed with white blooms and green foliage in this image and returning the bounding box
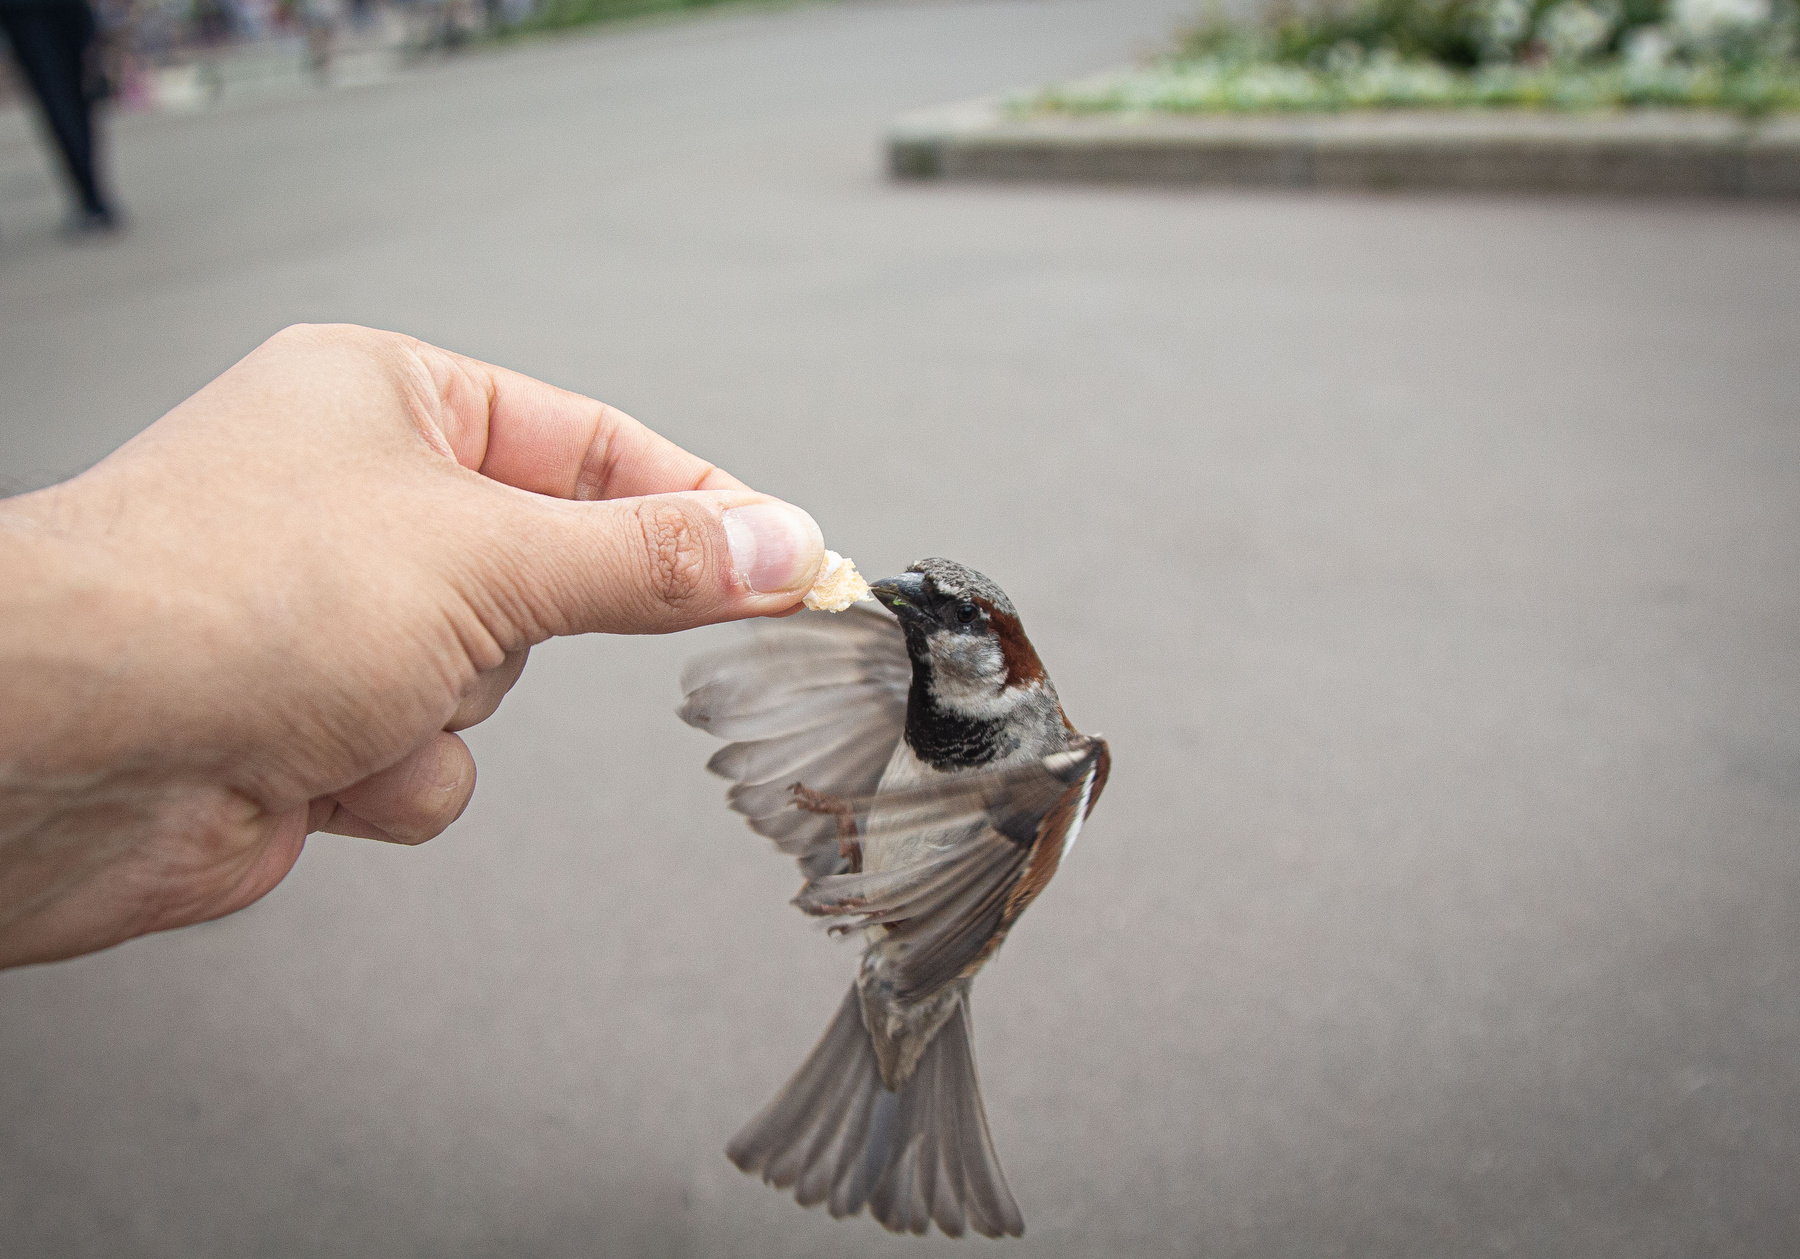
[1013,0,1800,115]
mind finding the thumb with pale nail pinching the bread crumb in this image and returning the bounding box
[486,490,824,634]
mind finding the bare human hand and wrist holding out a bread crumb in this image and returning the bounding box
[0,326,823,965]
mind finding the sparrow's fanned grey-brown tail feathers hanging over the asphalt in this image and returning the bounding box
[725,985,1024,1237]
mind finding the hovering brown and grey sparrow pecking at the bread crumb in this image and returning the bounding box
[679,558,1111,1237]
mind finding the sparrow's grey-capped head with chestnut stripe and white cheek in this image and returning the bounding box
[869,558,1055,720]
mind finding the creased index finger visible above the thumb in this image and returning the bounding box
[416,342,749,499]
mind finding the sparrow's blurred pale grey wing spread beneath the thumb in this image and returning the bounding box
[677,603,913,879]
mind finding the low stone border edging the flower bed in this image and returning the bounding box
[887,97,1800,196]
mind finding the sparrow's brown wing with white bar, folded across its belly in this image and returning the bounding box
[794,735,1112,1001]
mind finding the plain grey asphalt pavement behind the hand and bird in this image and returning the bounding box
[0,0,1800,1259]
